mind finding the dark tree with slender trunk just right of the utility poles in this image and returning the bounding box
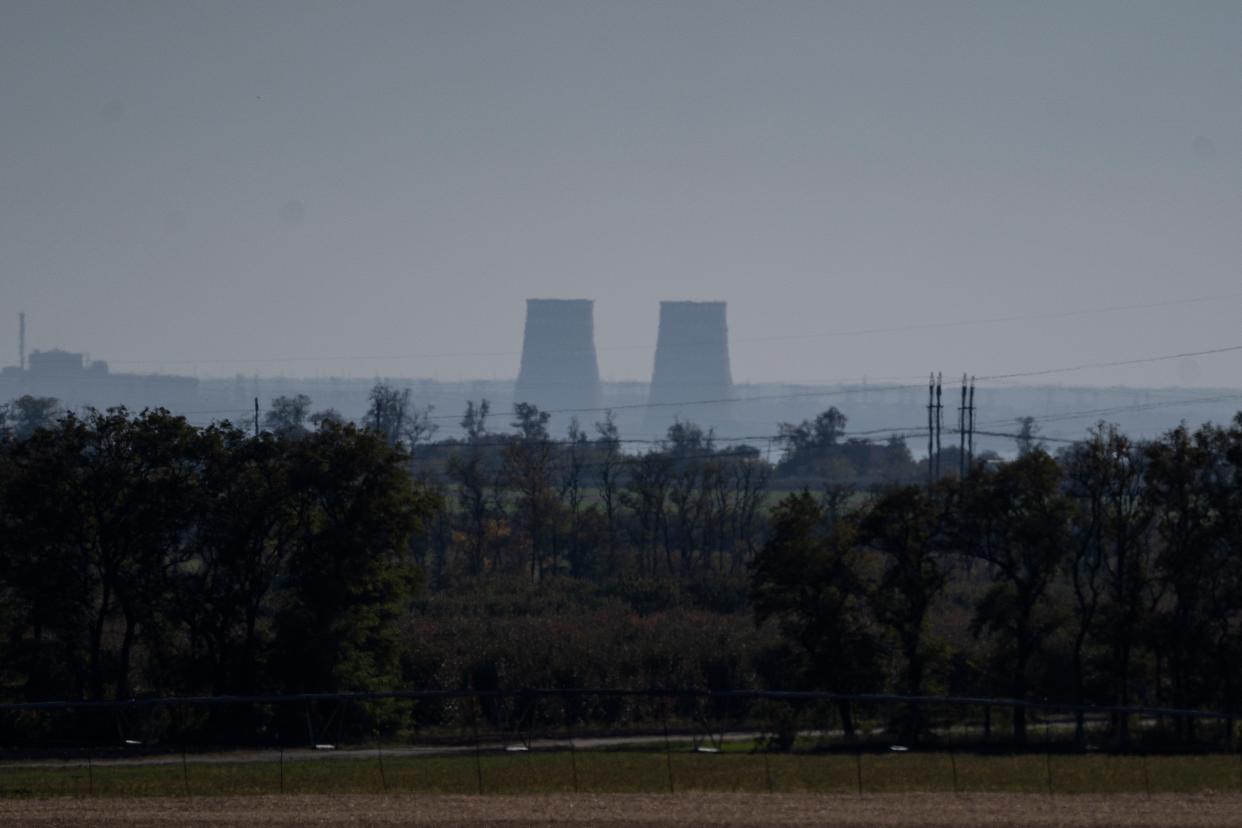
[956,449,1072,744]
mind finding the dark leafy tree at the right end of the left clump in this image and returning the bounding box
[273,425,437,691]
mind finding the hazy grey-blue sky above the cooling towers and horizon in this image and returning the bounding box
[0,0,1242,385]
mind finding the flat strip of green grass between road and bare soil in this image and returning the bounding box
[7,750,1242,797]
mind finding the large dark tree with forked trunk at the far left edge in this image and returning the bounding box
[6,408,197,699]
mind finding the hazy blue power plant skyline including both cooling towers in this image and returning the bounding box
[0,299,1237,453]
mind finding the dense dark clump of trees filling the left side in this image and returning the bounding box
[0,410,437,699]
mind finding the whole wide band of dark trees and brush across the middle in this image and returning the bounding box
[0,385,1242,736]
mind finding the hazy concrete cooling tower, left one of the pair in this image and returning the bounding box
[514,299,600,414]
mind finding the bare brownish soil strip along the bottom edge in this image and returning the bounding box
[0,793,1242,828]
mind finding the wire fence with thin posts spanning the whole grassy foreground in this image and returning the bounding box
[0,689,1242,796]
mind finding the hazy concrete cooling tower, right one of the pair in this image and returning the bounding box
[646,302,733,430]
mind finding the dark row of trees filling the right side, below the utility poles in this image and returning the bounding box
[751,416,1242,739]
